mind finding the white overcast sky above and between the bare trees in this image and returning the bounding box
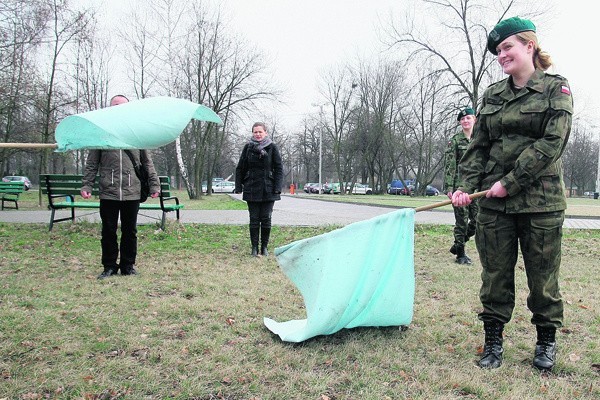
[89,0,600,129]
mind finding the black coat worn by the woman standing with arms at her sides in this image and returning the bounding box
[235,143,283,201]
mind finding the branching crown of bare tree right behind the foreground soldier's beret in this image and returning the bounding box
[386,0,540,109]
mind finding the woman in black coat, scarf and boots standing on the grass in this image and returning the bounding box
[235,122,283,257]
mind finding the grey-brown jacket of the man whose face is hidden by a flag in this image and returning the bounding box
[81,150,160,201]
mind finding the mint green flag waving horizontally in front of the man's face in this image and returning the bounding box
[55,97,223,152]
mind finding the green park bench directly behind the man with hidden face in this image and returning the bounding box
[40,174,183,231]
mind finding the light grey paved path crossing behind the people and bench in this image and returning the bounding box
[0,195,600,229]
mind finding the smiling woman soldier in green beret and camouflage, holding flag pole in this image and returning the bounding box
[452,17,573,370]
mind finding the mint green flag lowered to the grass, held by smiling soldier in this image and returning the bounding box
[264,209,415,342]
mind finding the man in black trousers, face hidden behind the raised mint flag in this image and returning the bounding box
[81,95,160,279]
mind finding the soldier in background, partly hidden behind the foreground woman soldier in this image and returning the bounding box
[444,107,478,264]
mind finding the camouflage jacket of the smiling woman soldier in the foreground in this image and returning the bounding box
[459,70,573,214]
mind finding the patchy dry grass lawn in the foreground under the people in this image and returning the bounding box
[0,223,600,400]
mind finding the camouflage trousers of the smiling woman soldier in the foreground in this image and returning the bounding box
[475,208,565,328]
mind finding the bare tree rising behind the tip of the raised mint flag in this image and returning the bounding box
[181,2,275,198]
